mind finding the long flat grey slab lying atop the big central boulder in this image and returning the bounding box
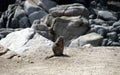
[50,4,89,18]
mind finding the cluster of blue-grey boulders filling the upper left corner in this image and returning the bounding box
[0,0,56,28]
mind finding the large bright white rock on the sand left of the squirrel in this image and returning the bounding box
[0,28,53,55]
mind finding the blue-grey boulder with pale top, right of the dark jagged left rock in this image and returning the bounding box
[24,0,47,24]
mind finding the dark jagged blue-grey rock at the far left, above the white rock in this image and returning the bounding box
[0,4,30,28]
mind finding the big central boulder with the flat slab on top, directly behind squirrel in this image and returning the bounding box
[42,4,89,41]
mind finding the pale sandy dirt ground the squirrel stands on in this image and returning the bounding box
[0,47,120,75]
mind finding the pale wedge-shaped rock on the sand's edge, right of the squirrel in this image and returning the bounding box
[69,33,103,47]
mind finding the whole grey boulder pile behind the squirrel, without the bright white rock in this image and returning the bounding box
[0,0,120,47]
